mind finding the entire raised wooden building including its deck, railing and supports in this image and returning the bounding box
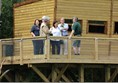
[0,0,118,82]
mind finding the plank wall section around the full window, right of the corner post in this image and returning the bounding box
[56,0,111,37]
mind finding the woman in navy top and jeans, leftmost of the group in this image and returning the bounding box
[31,19,43,55]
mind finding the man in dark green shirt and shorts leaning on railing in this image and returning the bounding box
[69,17,82,55]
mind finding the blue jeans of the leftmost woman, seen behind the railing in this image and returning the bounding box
[32,40,44,55]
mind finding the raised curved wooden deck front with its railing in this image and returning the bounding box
[0,37,118,65]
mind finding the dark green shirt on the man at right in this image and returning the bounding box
[72,22,82,35]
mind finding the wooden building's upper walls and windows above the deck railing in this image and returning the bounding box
[14,0,118,37]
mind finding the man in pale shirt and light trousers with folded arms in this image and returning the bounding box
[58,17,69,55]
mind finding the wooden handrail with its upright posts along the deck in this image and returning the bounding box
[0,36,118,65]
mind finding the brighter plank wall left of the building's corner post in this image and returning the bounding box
[14,0,54,38]
